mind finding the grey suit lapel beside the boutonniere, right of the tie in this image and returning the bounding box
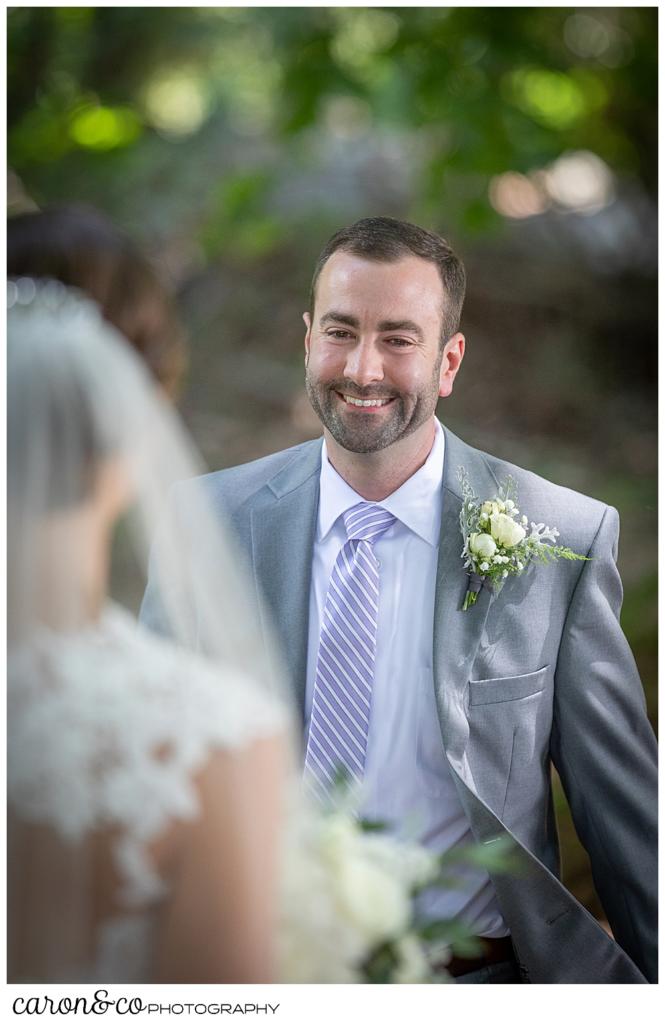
[433,428,497,792]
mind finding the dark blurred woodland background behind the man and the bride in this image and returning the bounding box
[8,7,658,929]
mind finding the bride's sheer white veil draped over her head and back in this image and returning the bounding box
[7,279,296,980]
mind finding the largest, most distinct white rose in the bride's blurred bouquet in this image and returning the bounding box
[335,857,411,944]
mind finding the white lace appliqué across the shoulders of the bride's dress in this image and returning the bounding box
[8,605,286,981]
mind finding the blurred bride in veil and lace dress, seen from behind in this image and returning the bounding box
[7,280,293,983]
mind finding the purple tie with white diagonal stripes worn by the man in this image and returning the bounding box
[304,502,394,798]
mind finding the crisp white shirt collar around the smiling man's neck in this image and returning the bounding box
[317,419,446,547]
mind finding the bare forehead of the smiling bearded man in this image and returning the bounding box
[316,252,444,324]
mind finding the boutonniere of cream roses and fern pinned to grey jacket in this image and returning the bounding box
[457,467,589,611]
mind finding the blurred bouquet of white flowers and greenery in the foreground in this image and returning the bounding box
[278,796,514,984]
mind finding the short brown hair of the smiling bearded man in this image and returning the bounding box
[309,217,466,346]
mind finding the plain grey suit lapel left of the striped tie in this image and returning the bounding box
[250,441,321,711]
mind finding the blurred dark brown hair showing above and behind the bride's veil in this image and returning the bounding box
[7,205,186,396]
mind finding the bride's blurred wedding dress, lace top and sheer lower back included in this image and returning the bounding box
[8,603,286,983]
